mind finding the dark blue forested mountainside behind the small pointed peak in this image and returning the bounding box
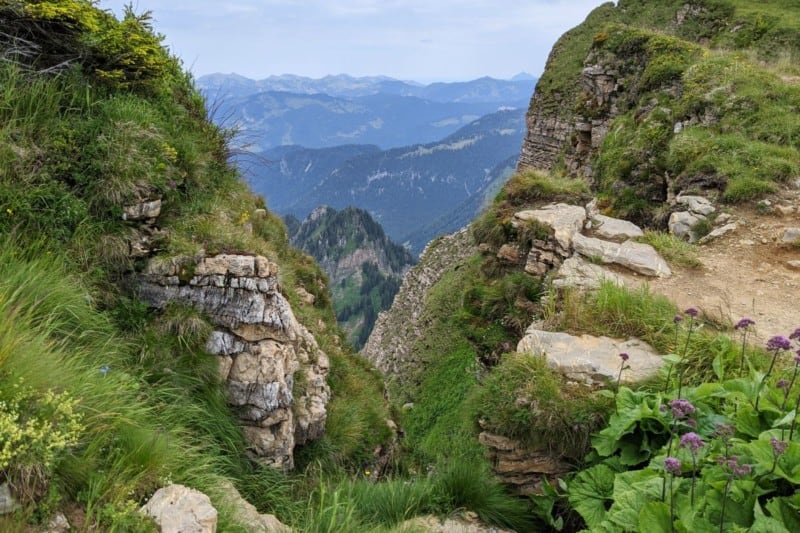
[251,109,525,253]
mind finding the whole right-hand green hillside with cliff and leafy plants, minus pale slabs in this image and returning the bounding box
[362,0,800,531]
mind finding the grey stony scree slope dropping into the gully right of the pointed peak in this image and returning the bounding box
[361,228,477,379]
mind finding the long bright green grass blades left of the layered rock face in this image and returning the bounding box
[0,238,294,527]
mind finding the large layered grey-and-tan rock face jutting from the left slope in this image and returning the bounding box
[138,255,330,469]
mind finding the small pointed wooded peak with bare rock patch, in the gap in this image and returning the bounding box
[286,206,414,349]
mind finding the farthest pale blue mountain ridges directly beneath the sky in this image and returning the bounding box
[197,74,536,153]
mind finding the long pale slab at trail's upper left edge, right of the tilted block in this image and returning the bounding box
[573,234,672,278]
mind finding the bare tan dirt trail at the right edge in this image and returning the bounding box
[626,204,800,343]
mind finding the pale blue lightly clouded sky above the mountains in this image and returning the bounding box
[98,0,603,83]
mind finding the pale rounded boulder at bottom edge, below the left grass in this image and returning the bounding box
[141,485,217,533]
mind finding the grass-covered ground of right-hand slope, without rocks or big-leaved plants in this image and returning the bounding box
[382,0,800,528]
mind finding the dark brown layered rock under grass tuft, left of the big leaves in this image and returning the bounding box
[478,431,570,495]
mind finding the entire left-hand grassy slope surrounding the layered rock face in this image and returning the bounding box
[0,0,389,531]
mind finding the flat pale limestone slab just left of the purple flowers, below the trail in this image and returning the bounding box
[517,327,663,384]
